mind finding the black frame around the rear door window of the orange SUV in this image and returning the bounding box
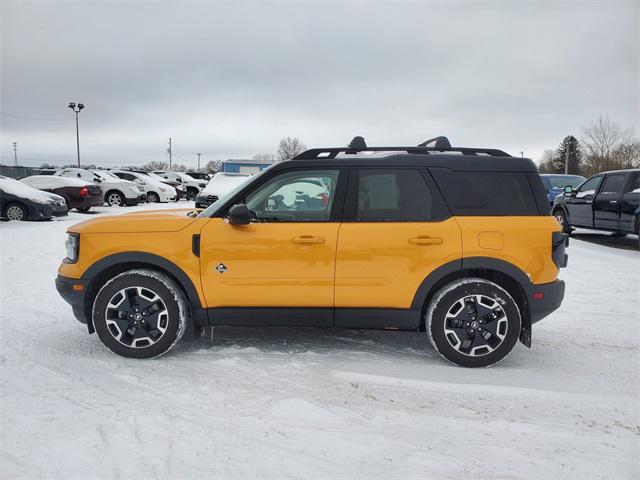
[342,165,451,223]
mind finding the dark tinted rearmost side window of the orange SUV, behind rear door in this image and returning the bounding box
[430,168,538,216]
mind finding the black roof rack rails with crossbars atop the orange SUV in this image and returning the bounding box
[293,137,511,160]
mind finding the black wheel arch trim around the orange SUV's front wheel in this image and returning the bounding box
[81,252,206,333]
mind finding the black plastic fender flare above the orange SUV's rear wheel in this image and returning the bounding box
[411,257,531,310]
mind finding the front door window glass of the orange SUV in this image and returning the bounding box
[245,170,340,222]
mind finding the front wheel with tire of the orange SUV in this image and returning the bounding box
[92,269,188,358]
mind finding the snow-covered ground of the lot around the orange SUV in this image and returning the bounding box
[0,202,640,479]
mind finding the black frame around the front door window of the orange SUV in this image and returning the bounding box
[211,165,348,225]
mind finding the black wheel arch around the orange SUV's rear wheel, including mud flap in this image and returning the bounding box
[411,257,531,347]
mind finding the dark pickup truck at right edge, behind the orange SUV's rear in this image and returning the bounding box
[553,169,640,244]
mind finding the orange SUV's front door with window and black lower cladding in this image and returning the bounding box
[200,169,342,325]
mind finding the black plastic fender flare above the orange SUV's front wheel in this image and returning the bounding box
[80,252,207,333]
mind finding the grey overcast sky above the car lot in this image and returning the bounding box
[0,2,640,166]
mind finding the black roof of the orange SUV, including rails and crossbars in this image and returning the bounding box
[286,137,538,173]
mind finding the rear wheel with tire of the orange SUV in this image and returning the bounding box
[426,278,522,368]
